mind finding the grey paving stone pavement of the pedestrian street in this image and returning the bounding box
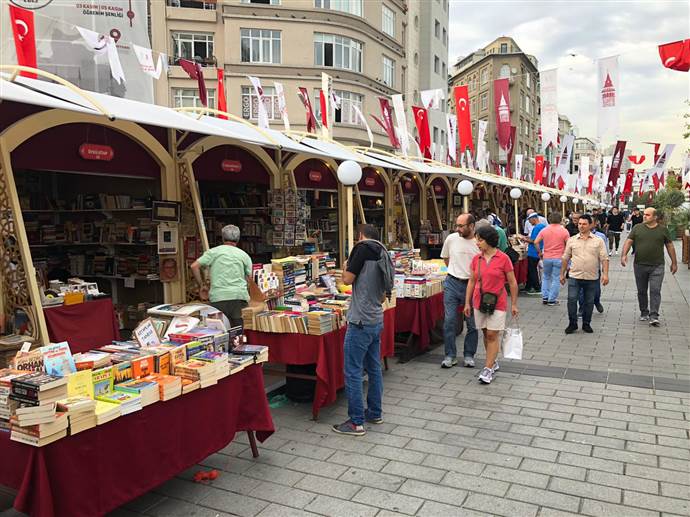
[2,240,690,517]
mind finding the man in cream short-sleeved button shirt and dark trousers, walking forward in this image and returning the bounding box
[560,214,609,334]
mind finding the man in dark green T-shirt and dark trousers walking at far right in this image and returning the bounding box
[621,207,678,327]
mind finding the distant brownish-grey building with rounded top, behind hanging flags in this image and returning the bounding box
[449,36,540,177]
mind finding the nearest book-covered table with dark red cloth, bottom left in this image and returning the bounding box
[0,304,274,516]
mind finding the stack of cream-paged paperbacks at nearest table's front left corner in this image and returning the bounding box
[10,410,69,447]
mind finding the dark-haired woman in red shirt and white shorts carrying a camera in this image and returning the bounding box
[465,225,518,384]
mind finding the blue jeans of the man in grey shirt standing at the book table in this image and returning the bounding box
[345,323,383,425]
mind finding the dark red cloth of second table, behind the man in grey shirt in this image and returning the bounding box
[244,307,397,420]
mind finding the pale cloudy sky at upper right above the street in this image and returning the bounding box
[446,0,690,167]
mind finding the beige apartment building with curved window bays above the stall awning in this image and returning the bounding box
[151,0,414,148]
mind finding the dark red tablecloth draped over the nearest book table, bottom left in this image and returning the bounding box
[0,366,274,517]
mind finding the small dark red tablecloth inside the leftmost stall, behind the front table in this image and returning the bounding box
[43,298,120,354]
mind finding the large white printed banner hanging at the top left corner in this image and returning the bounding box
[0,0,152,103]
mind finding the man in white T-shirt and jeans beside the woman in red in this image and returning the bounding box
[441,214,478,368]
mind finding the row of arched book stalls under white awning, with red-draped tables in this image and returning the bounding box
[0,69,584,515]
